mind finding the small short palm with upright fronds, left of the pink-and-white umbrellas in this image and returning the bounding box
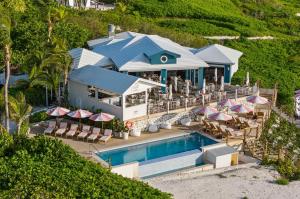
[9,92,32,134]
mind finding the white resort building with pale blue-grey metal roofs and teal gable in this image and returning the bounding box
[69,28,242,121]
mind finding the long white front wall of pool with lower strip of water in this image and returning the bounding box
[139,150,202,178]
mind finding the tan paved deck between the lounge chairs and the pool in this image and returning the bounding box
[30,122,243,159]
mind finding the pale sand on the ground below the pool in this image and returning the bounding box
[144,164,300,199]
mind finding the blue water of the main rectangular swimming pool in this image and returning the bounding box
[97,133,217,166]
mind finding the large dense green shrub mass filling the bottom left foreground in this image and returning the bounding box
[0,135,170,198]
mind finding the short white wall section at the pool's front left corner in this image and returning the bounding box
[111,162,139,179]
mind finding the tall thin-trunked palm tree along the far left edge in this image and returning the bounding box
[0,0,26,132]
